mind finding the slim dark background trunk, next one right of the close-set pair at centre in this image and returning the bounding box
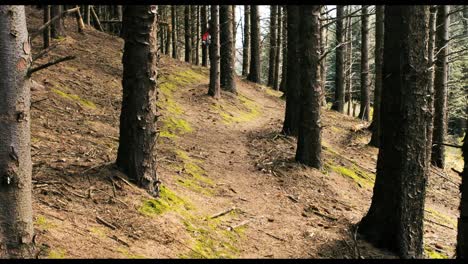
[247,5,261,83]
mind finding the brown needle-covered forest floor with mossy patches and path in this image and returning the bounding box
[24,9,460,258]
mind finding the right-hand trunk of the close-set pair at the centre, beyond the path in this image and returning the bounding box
[219,5,237,93]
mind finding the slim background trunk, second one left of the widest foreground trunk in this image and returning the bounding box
[358,6,370,121]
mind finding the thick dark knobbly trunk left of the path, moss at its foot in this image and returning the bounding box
[117,5,159,196]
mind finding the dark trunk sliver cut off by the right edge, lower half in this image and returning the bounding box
[457,130,468,259]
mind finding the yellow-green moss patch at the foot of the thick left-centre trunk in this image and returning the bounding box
[138,186,193,216]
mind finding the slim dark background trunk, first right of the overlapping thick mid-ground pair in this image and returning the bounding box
[331,5,345,113]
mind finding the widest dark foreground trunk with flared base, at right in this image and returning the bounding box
[359,5,431,258]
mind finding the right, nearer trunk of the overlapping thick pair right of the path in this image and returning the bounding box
[296,5,322,169]
